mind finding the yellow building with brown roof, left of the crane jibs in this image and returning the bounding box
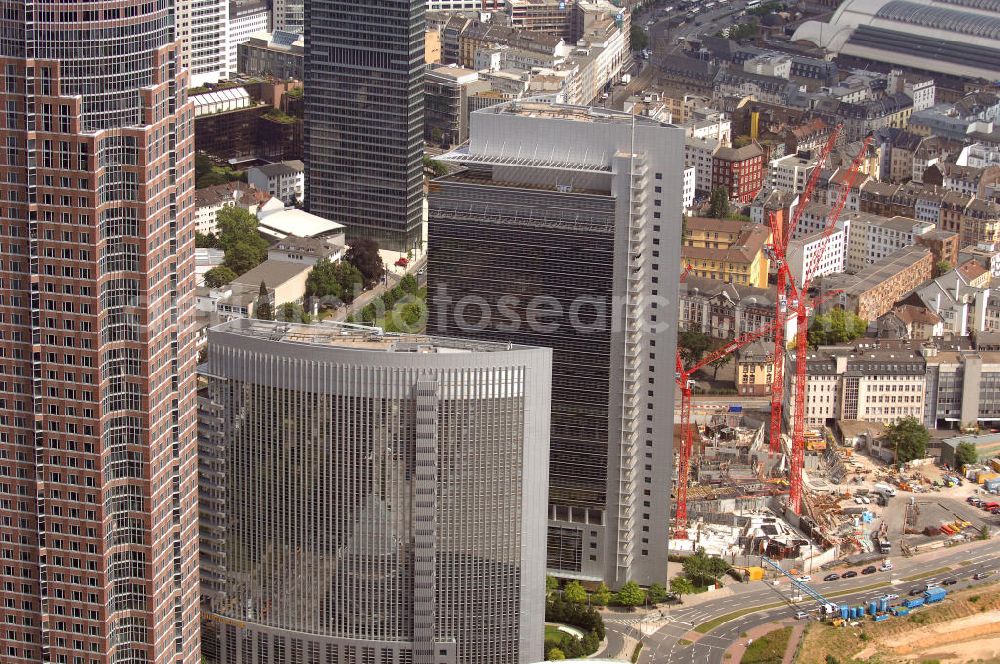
[680,217,771,288]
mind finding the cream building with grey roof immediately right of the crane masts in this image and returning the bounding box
[785,343,925,428]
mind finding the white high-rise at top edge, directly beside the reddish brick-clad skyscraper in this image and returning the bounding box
[179,0,228,87]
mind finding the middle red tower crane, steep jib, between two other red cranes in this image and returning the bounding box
[768,125,842,452]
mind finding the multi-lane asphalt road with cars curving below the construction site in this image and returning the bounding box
[605,542,1000,664]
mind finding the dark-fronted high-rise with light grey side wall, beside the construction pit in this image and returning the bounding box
[427,101,684,586]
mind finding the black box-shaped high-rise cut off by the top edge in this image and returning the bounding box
[304,0,425,251]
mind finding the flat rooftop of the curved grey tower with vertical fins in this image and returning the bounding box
[212,318,528,353]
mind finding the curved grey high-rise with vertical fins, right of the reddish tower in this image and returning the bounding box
[201,319,551,664]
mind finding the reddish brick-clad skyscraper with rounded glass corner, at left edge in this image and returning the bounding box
[0,0,200,664]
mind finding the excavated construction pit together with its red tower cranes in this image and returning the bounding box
[670,128,888,569]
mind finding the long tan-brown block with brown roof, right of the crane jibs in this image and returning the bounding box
[822,246,934,322]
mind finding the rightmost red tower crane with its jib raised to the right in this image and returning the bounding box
[784,135,872,514]
